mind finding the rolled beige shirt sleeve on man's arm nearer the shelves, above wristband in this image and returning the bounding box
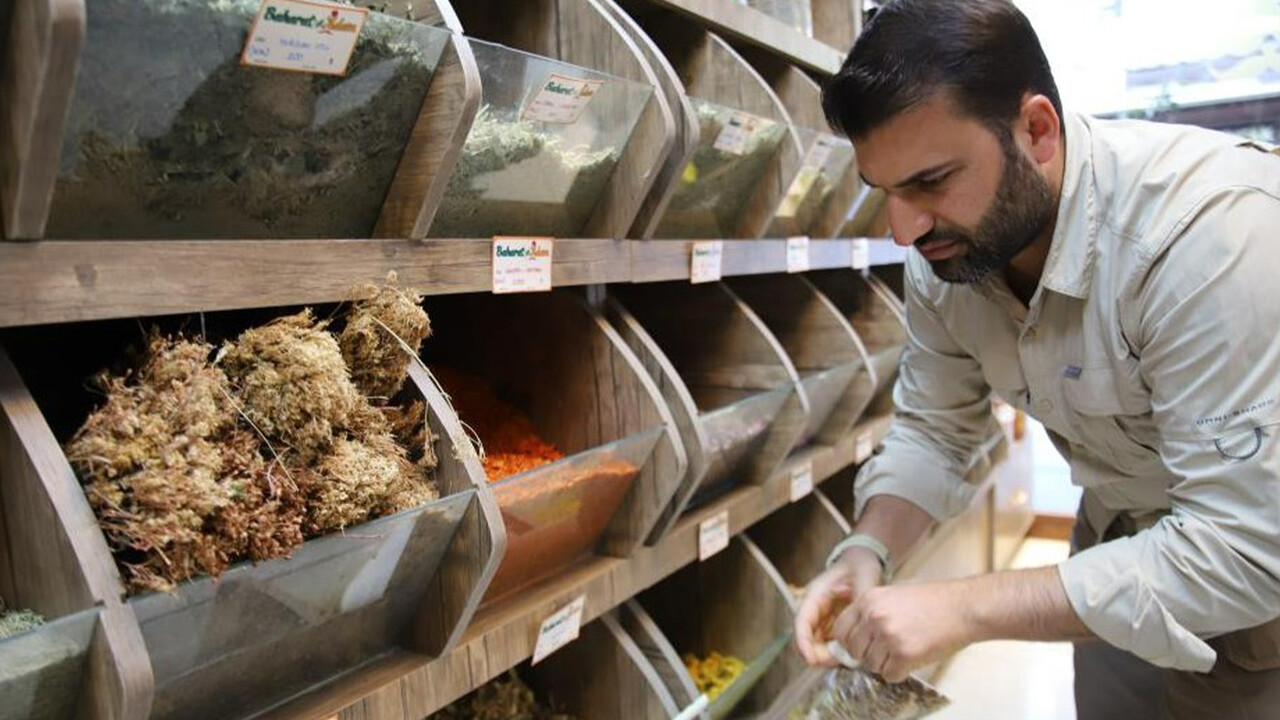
[854,256,996,521]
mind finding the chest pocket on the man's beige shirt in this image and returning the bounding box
[1061,361,1164,478]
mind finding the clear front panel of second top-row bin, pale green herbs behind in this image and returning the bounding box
[430,40,653,238]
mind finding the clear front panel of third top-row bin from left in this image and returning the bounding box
[655,97,787,240]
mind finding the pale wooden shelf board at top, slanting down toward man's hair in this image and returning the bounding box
[632,0,845,76]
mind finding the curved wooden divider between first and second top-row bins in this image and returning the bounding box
[374,35,480,238]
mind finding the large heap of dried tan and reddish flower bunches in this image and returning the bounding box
[67,280,436,592]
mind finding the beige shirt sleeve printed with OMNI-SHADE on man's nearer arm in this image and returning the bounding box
[1059,188,1280,673]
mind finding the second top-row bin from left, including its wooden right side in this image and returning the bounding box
[430,0,676,238]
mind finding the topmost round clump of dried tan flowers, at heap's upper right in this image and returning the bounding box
[338,278,431,398]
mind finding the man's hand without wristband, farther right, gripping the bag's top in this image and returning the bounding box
[832,584,974,683]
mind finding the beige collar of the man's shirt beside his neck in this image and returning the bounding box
[1041,111,1098,300]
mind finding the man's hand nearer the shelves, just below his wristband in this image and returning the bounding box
[796,547,882,667]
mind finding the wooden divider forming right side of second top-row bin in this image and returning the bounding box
[442,0,677,238]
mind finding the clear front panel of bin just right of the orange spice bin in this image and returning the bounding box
[698,384,794,491]
